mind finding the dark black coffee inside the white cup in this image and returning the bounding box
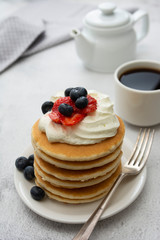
[120,69,160,91]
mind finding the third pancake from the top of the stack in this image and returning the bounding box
[34,152,122,181]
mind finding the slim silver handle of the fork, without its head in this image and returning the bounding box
[73,173,126,240]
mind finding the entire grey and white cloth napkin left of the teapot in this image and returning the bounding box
[0,0,95,72]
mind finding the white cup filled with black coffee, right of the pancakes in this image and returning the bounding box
[114,60,160,126]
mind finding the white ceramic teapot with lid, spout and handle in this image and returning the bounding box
[71,2,149,72]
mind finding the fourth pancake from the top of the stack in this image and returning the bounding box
[34,161,118,188]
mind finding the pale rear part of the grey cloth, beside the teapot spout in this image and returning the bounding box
[15,0,94,56]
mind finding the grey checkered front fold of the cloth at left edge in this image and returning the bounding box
[0,17,44,72]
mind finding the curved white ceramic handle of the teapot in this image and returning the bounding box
[133,10,149,42]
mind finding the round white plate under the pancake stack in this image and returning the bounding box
[14,139,147,224]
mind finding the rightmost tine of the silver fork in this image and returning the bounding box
[138,129,155,169]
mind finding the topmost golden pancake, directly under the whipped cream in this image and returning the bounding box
[32,117,125,161]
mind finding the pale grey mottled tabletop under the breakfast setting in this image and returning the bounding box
[0,0,160,240]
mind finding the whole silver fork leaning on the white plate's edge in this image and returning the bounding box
[73,128,154,240]
